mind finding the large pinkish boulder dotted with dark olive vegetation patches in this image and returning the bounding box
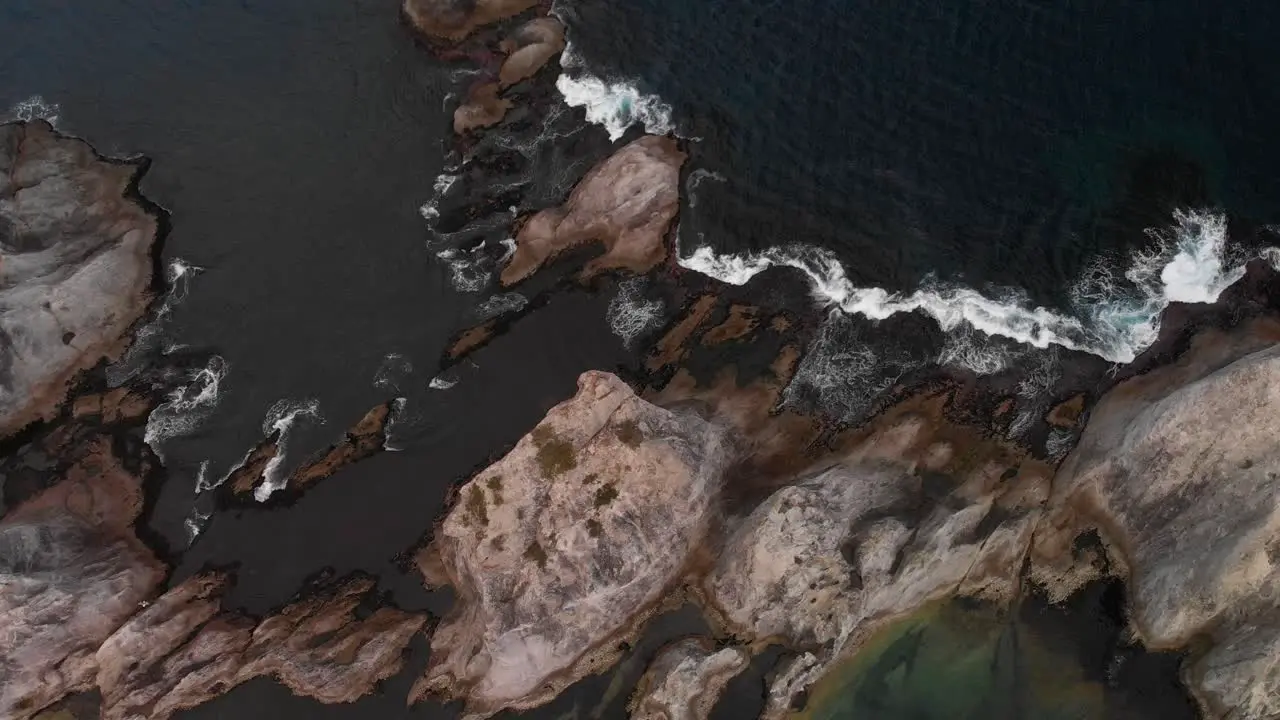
[415,372,726,717]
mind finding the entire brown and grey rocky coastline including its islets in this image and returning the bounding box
[0,0,1280,720]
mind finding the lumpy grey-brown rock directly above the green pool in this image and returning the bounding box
[703,413,1048,717]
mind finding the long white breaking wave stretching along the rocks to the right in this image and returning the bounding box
[678,210,1269,363]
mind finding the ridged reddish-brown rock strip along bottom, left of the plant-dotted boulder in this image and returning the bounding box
[97,577,425,720]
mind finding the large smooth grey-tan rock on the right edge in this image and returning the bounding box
[1037,338,1280,717]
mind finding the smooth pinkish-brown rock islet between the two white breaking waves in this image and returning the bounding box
[502,136,685,286]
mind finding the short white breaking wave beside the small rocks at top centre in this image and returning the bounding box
[556,42,675,140]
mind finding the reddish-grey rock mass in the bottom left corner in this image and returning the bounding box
[0,438,165,717]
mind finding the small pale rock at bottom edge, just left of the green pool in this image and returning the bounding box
[631,638,750,720]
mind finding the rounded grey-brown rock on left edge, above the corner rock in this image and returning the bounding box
[0,122,157,434]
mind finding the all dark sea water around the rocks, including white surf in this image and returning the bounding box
[0,0,1264,719]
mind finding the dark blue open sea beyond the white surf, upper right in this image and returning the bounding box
[561,0,1280,304]
